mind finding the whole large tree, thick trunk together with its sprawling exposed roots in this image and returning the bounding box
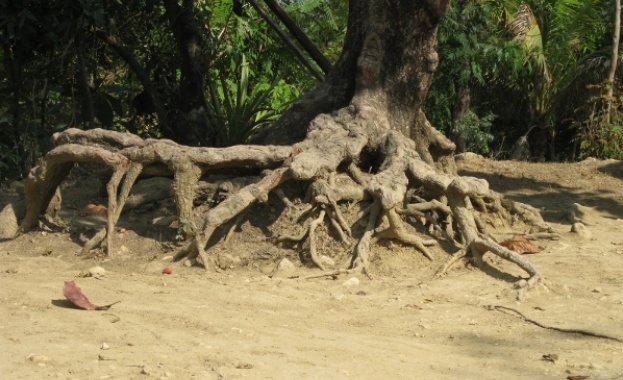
[22,0,548,298]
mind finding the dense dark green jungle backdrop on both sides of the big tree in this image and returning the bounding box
[0,0,623,181]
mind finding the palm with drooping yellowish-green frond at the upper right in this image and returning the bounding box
[490,0,612,155]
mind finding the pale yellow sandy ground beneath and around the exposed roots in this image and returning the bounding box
[0,158,623,380]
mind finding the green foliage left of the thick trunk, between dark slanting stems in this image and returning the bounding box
[0,0,348,181]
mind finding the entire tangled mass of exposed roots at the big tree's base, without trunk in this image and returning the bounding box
[21,110,551,300]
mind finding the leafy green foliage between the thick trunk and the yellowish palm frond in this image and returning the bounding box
[424,1,523,145]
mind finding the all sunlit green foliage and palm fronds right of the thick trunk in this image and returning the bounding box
[425,0,612,159]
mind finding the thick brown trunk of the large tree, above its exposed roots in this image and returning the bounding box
[257,0,454,172]
